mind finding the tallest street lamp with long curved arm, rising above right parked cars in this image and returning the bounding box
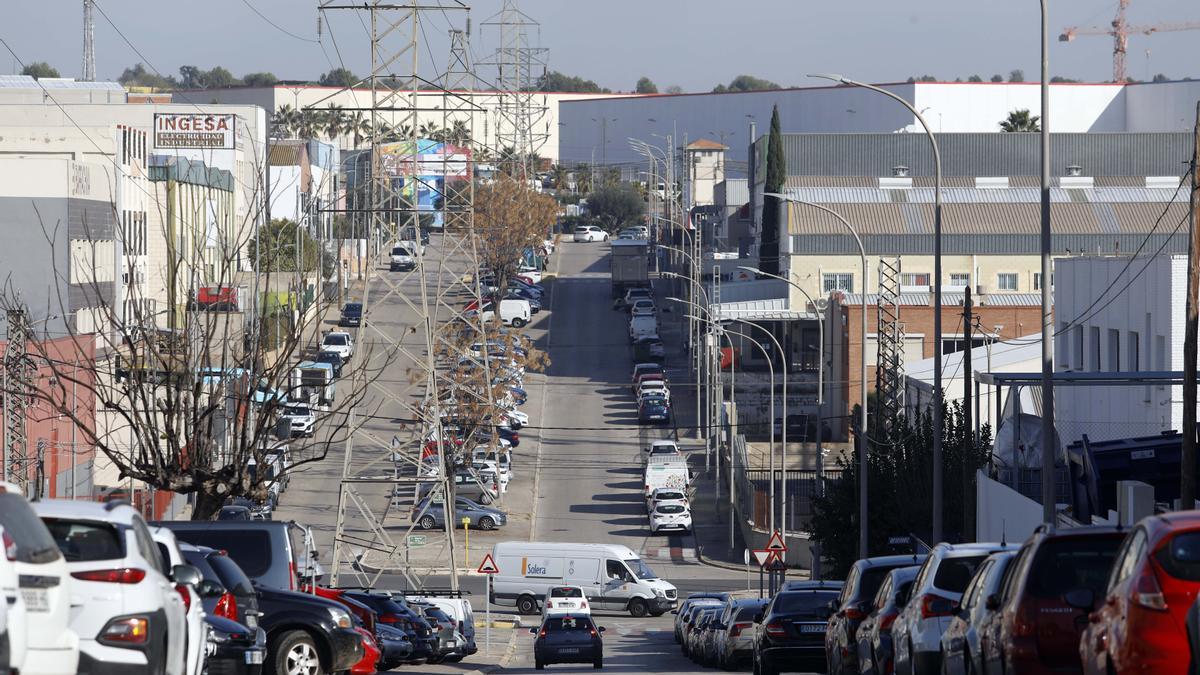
[809,73,945,542]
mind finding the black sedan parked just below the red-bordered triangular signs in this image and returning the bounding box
[754,587,838,675]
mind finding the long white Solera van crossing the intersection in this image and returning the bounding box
[488,542,678,616]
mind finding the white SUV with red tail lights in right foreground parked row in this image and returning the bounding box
[892,543,1016,675]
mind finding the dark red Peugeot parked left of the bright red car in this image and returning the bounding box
[980,526,1124,675]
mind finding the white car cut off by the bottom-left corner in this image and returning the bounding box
[0,482,79,675]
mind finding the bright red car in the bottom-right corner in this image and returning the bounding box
[1079,510,1200,675]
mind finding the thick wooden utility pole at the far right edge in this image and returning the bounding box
[1180,102,1200,509]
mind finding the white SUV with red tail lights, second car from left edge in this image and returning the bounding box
[34,500,192,675]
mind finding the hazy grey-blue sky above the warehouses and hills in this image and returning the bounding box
[0,0,1200,91]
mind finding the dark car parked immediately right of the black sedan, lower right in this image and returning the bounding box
[824,555,925,675]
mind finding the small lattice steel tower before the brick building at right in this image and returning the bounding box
[878,257,904,441]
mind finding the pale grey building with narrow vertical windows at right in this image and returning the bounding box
[1055,256,1187,443]
